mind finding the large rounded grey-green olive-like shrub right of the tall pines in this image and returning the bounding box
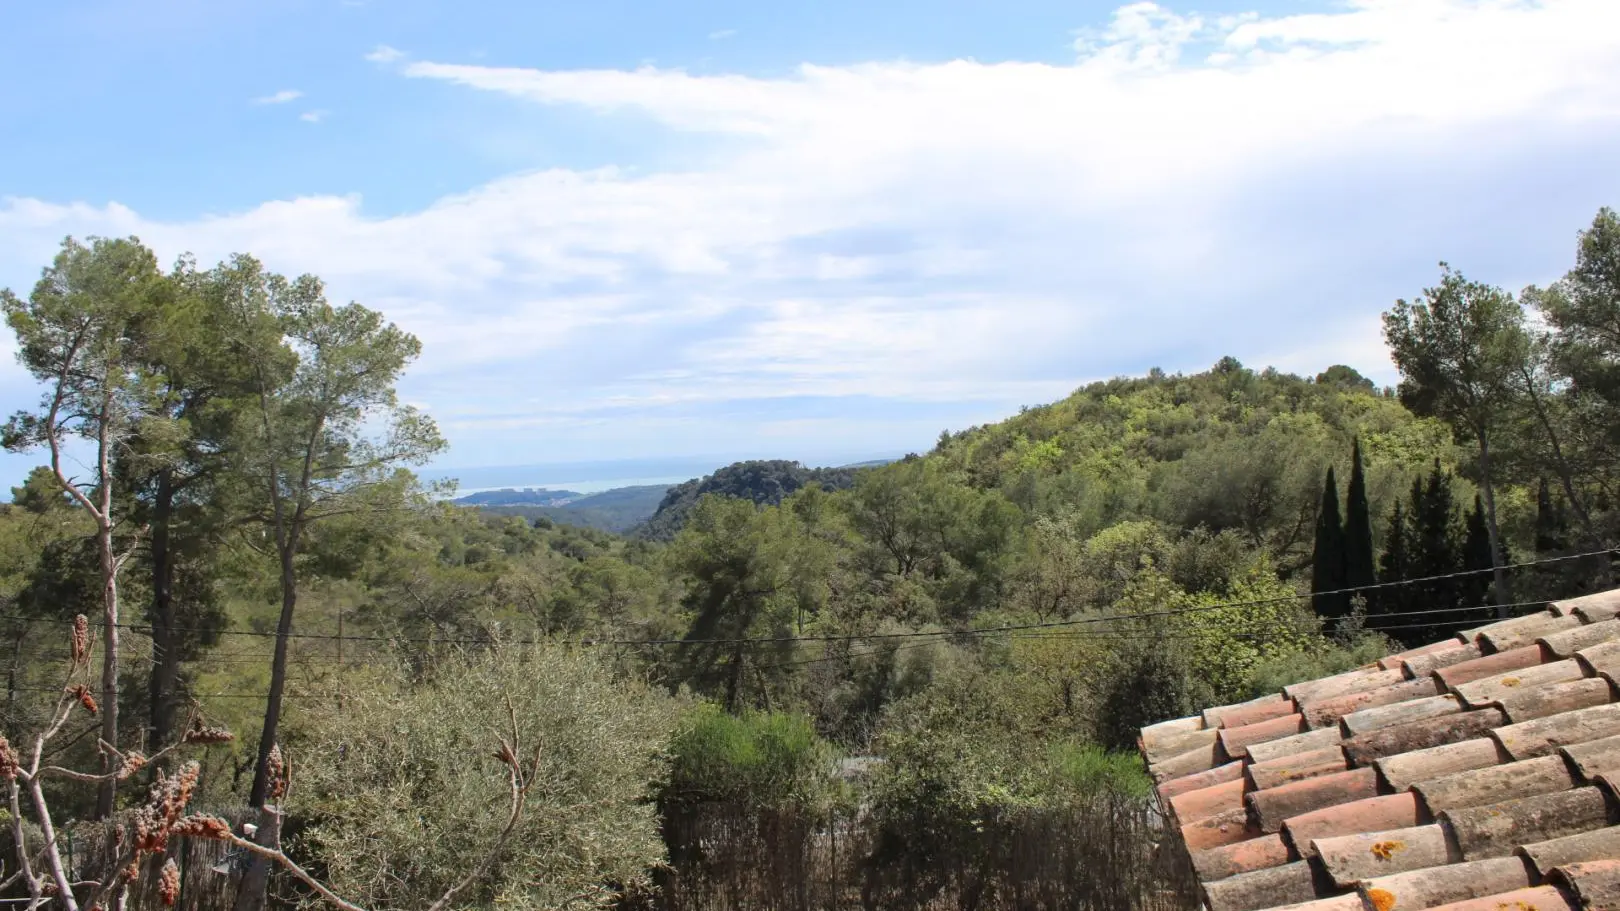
[295,644,679,909]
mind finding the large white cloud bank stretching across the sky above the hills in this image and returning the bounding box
[0,0,1620,460]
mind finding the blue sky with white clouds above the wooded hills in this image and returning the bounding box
[0,0,1620,489]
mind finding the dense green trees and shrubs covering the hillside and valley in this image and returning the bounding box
[0,209,1620,908]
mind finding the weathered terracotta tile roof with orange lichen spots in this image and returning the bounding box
[1139,590,1620,911]
